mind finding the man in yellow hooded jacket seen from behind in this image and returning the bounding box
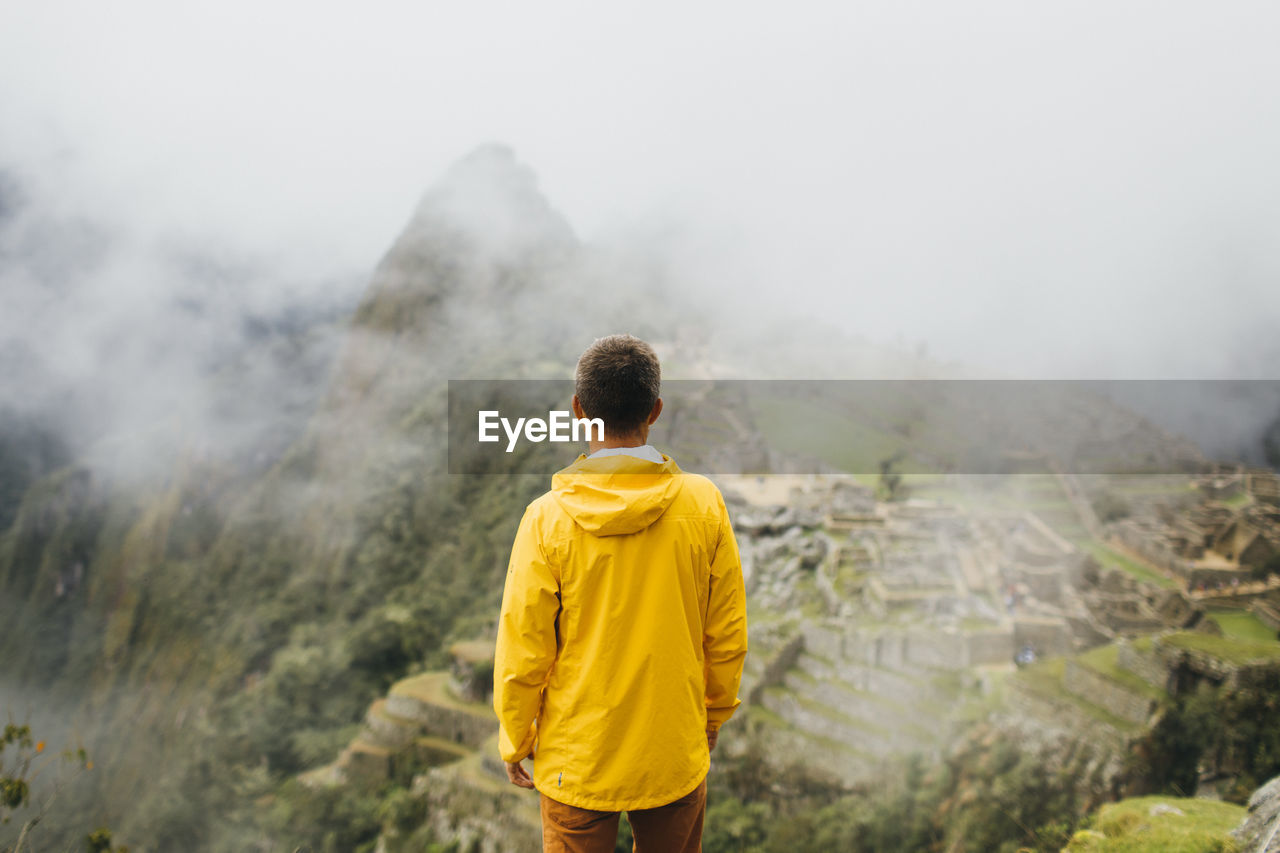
[494,334,746,853]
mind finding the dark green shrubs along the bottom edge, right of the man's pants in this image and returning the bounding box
[703,726,1102,853]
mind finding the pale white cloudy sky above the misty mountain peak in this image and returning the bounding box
[0,0,1280,378]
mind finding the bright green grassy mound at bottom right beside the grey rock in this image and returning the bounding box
[1066,797,1245,853]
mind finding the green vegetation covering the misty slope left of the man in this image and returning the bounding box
[0,422,545,850]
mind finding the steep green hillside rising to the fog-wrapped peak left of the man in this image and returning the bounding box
[0,147,644,850]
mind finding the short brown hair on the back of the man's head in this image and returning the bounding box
[573,334,662,435]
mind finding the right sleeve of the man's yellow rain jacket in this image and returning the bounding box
[703,497,746,729]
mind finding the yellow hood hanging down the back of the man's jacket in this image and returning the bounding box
[552,453,684,537]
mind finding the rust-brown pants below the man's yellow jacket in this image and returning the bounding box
[539,779,707,853]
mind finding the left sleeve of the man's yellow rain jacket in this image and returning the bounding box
[493,507,559,761]
